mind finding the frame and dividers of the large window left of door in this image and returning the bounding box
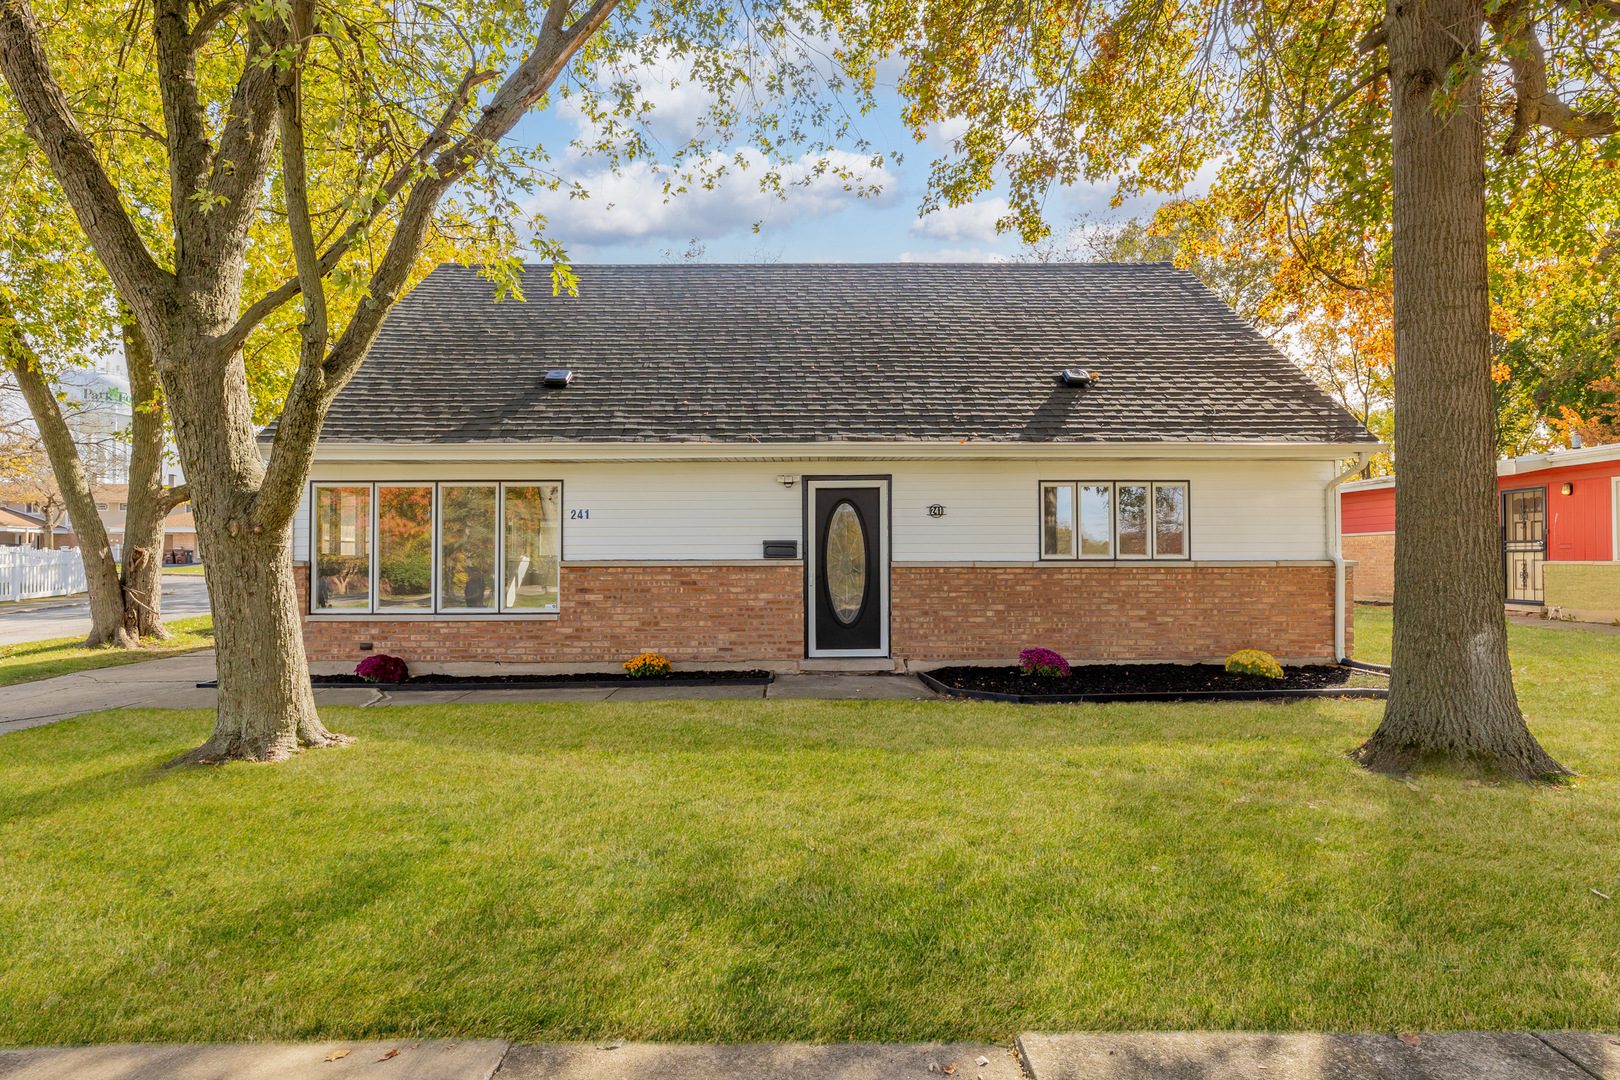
[305,479,569,619]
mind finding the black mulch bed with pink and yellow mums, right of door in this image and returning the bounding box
[922,664,1388,703]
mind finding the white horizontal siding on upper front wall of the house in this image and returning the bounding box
[293,458,1337,563]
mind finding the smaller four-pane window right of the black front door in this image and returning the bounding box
[1040,479,1189,559]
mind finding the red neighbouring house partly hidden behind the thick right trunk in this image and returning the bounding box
[1340,445,1620,622]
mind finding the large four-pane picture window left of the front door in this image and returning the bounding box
[309,481,562,614]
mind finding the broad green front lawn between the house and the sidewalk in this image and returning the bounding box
[0,609,1620,1043]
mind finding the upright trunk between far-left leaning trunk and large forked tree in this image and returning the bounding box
[122,313,188,640]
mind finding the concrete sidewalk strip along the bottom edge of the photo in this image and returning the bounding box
[0,1031,1620,1080]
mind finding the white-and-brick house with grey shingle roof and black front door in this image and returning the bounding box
[281,264,1380,670]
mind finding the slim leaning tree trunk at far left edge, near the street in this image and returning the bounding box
[0,312,138,646]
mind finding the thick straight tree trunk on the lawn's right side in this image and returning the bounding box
[1358,0,1567,779]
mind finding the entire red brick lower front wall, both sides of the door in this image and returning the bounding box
[296,563,1359,667]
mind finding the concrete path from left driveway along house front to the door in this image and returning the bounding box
[0,651,935,733]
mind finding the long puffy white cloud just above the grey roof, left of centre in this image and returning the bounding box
[528,147,897,246]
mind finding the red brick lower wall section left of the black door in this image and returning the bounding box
[296,563,805,664]
